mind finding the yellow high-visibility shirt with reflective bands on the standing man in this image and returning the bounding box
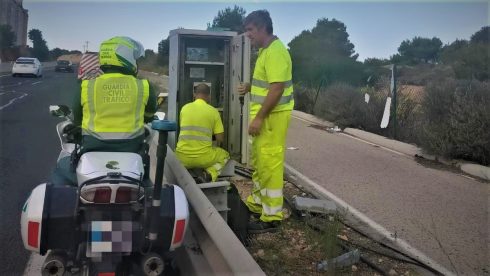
[250,39,294,115]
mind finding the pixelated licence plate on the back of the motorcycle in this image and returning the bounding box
[90,221,133,252]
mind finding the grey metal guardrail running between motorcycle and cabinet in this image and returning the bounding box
[150,142,265,275]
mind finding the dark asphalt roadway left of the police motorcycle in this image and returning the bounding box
[0,68,77,275]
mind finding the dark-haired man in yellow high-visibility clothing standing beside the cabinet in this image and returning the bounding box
[238,10,294,233]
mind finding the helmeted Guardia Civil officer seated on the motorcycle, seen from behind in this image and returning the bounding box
[52,37,157,184]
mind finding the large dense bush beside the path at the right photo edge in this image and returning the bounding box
[421,79,490,165]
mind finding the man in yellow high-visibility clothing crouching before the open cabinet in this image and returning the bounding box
[175,83,230,182]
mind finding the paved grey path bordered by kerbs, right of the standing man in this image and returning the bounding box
[286,118,490,275]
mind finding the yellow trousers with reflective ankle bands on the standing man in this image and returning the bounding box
[246,111,291,222]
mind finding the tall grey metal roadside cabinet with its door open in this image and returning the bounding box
[167,29,250,163]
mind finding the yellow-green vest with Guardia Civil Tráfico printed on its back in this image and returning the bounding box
[81,73,150,140]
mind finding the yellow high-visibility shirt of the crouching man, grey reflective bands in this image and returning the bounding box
[176,99,224,156]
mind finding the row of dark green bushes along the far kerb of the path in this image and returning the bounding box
[295,78,490,165]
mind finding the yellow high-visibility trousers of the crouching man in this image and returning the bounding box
[175,147,230,181]
